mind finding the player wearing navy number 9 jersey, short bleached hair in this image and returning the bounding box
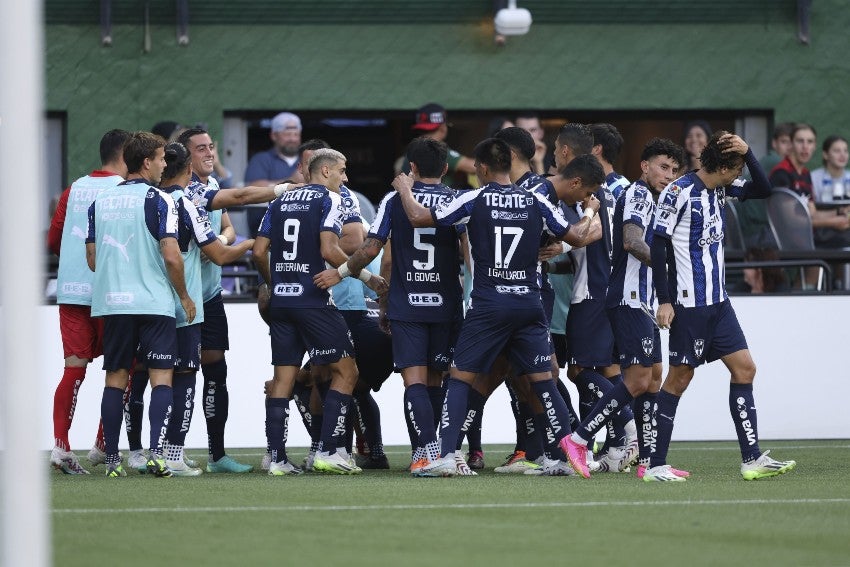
[254,149,383,475]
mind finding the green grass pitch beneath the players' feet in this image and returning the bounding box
[51,440,850,567]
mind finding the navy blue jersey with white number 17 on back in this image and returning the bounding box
[431,183,570,309]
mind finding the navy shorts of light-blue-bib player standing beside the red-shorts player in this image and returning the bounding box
[103,315,177,372]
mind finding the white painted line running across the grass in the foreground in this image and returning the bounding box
[53,498,850,515]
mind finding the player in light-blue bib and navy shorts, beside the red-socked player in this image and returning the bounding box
[86,132,196,477]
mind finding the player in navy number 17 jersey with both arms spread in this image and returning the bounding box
[393,138,602,476]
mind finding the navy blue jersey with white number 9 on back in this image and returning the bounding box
[257,185,343,308]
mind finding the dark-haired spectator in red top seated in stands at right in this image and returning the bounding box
[770,122,850,248]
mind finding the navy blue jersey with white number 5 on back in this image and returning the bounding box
[369,181,463,323]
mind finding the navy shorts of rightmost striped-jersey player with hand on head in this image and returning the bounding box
[670,300,747,367]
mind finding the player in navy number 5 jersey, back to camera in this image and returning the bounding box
[315,137,463,475]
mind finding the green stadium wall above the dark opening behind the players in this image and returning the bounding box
[45,0,850,179]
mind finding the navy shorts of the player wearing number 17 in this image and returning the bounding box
[454,306,552,374]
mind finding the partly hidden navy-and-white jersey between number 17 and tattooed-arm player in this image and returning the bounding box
[565,187,614,303]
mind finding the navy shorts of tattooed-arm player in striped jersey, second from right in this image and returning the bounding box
[608,305,661,368]
